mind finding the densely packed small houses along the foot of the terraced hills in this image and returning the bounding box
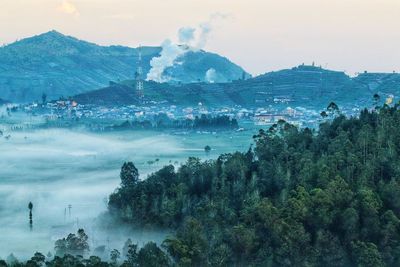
[0,99,366,133]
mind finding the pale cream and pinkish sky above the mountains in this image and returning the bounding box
[0,0,400,75]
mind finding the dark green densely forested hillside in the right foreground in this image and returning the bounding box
[109,105,400,266]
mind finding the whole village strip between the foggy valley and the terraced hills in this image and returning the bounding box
[0,96,359,135]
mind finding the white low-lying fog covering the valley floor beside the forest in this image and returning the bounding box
[0,130,252,259]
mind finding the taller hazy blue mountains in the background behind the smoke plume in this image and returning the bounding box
[0,31,248,102]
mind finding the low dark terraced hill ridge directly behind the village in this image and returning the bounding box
[75,65,400,108]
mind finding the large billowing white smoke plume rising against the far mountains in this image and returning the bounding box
[146,14,225,82]
